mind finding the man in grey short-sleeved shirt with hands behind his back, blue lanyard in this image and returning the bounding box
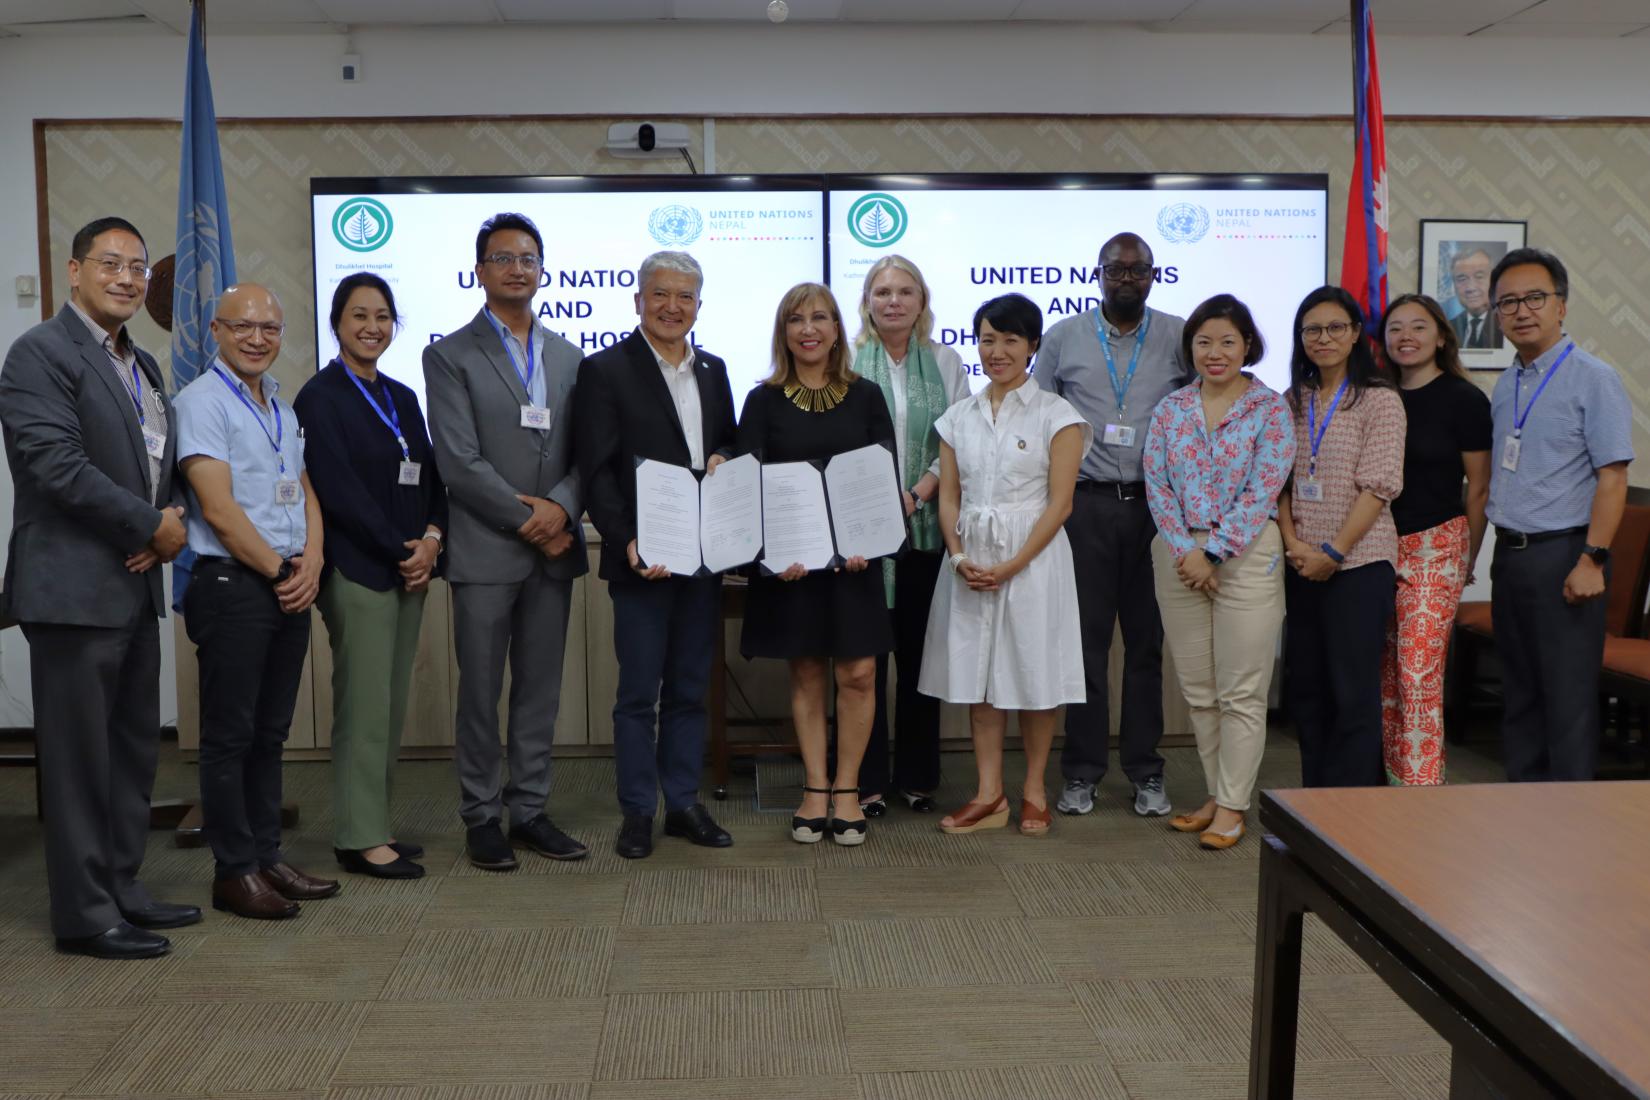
[1033,233,1193,816]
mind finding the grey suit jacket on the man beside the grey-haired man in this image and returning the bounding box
[424,312,589,584]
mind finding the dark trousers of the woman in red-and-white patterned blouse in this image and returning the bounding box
[1284,561,1398,787]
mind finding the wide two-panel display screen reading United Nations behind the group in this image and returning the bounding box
[310,173,1328,409]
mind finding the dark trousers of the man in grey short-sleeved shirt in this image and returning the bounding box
[1059,482,1163,783]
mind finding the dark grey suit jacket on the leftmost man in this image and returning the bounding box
[0,305,183,627]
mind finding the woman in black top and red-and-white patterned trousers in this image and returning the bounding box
[1381,294,1492,787]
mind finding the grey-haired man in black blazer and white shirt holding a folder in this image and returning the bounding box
[573,252,734,859]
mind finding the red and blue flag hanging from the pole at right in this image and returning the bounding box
[1341,0,1388,335]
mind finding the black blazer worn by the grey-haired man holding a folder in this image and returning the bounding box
[573,330,734,584]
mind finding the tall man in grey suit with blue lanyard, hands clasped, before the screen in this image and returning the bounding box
[424,214,589,871]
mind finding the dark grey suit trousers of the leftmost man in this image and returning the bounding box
[23,605,160,938]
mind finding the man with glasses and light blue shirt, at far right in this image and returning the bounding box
[1488,249,1634,782]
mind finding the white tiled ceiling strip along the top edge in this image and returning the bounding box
[0,0,1650,41]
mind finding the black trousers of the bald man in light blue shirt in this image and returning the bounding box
[183,557,310,879]
